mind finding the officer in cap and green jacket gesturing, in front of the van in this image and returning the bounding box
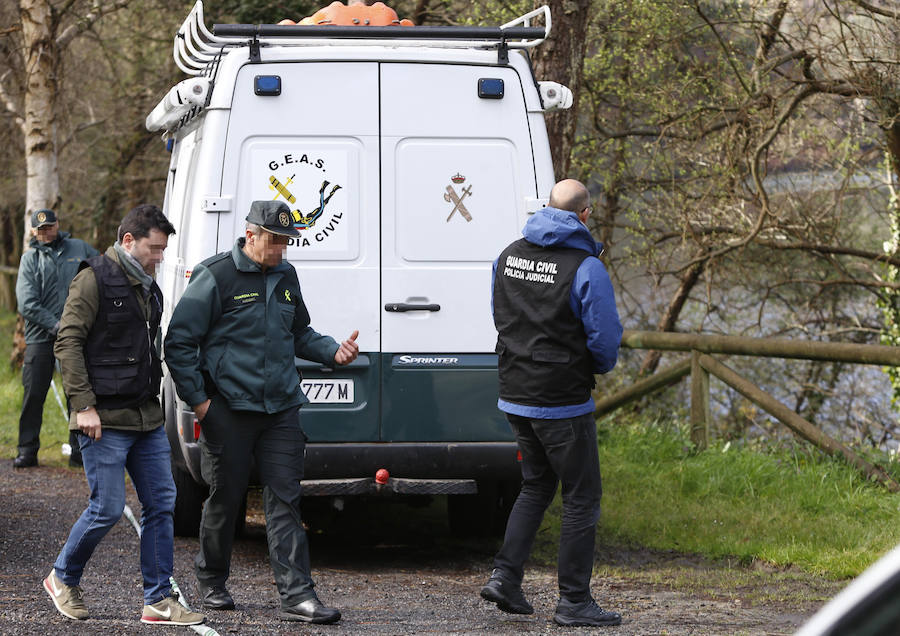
[165,201,359,623]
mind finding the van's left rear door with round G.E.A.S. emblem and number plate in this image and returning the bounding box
[225,62,380,441]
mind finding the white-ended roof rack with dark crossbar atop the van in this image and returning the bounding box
[172,0,551,75]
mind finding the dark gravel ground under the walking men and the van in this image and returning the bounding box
[0,459,842,636]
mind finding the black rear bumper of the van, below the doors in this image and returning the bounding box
[304,441,522,481]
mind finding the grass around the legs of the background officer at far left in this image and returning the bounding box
[0,311,69,466]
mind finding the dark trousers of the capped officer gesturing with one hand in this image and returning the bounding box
[194,396,315,607]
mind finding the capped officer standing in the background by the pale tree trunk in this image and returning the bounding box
[13,210,99,468]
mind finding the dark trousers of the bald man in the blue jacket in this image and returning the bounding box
[494,413,602,603]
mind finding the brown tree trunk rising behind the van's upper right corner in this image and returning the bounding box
[532,0,591,180]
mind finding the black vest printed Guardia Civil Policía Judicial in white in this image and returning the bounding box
[494,239,594,406]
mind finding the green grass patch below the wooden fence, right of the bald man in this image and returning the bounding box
[536,419,900,579]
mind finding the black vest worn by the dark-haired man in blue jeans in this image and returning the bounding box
[81,254,162,409]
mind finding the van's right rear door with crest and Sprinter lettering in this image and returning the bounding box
[381,63,536,441]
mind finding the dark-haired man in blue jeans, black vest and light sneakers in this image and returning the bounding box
[44,205,203,625]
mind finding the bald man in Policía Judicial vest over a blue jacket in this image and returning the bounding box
[481,179,622,626]
